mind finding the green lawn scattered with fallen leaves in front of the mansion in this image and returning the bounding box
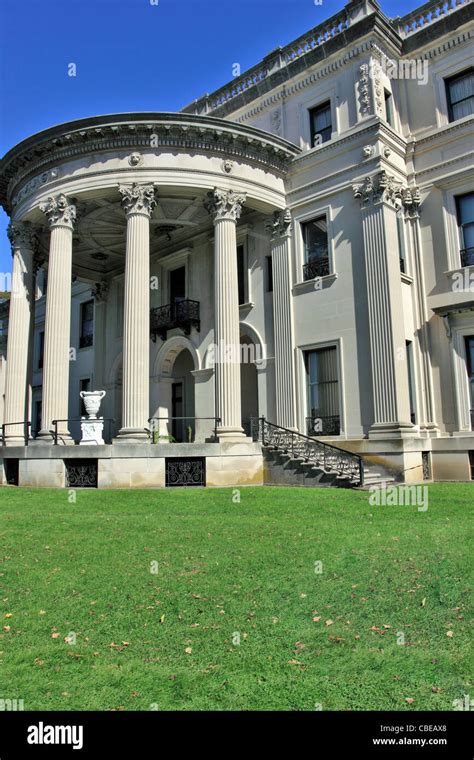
[0,484,474,710]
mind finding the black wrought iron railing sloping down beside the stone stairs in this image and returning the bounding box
[252,417,364,486]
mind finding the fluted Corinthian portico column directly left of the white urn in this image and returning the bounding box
[37,193,76,443]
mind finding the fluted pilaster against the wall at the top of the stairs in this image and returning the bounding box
[267,209,297,430]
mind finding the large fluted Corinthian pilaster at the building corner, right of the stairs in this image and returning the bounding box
[353,172,414,438]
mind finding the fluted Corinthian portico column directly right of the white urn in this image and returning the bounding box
[116,183,156,442]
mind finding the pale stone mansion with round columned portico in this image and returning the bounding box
[0,0,474,488]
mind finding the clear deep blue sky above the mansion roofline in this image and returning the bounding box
[0,0,421,272]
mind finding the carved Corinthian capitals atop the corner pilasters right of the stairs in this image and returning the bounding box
[352,171,421,219]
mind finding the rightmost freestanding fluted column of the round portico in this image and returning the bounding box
[205,188,245,439]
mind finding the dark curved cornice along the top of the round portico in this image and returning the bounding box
[0,113,300,213]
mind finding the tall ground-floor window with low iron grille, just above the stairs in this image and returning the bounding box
[304,346,341,436]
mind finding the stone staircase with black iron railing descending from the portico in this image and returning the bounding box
[252,417,394,490]
